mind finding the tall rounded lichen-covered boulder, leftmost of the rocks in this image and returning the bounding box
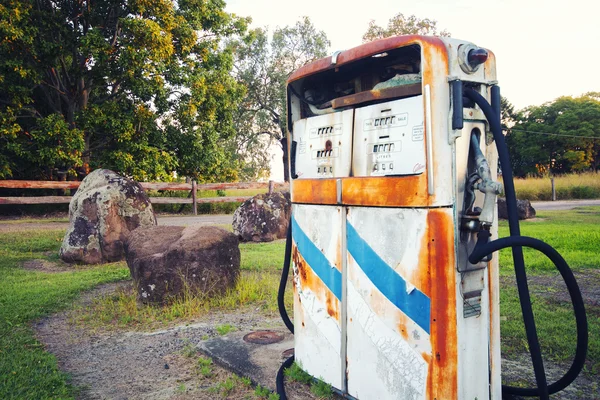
[60,169,156,264]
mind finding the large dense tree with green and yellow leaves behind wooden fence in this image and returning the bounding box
[0,0,248,180]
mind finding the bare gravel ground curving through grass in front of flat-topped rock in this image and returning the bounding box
[34,282,294,400]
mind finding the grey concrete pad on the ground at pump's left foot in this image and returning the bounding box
[198,330,294,390]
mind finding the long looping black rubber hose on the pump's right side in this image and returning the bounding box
[465,88,588,399]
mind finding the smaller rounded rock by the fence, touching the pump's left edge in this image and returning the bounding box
[233,192,291,242]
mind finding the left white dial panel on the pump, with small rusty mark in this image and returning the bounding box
[293,110,354,179]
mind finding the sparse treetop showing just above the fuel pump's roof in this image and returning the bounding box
[363,13,450,43]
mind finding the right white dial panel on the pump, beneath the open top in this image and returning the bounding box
[353,96,425,176]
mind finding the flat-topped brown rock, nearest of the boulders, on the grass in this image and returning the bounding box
[125,225,240,304]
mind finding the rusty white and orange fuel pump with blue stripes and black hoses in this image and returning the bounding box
[277,36,587,400]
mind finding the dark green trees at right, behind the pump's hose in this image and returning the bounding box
[506,93,600,176]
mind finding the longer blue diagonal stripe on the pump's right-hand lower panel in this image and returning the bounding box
[347,223,431,334]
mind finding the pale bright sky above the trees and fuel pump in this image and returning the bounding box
[226,0,600,108]
